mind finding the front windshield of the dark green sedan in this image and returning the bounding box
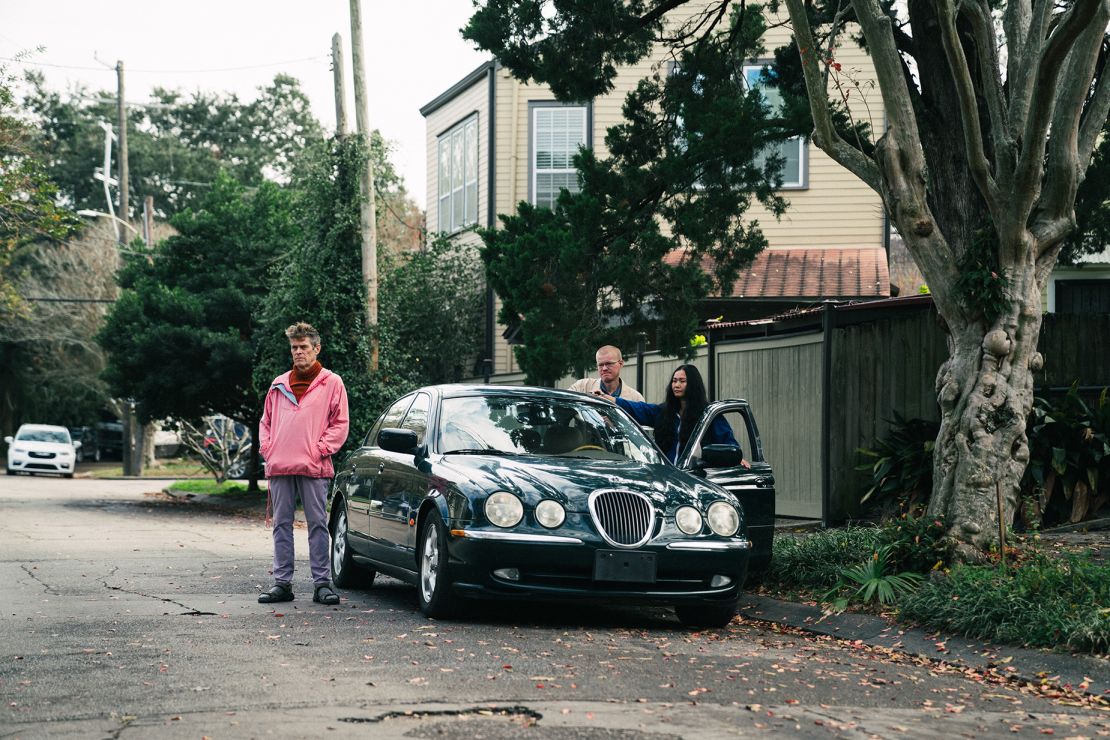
[438,395,665,463]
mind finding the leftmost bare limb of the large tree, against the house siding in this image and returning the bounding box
[786,0,882,194]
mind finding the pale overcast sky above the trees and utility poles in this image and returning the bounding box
[0,0,490,207]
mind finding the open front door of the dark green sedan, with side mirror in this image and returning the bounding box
[678,399,775,578]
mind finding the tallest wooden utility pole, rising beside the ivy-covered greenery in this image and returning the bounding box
[351,0,379,372]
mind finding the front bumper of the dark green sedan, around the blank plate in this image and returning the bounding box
[447,529,750,606]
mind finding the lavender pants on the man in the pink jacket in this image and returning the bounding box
[268,475,331,584]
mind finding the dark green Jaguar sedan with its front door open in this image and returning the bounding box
[329,385,775,626]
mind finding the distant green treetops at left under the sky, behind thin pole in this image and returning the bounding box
[26,73,323,215]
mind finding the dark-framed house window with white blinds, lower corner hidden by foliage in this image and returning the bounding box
[531,105,588,209]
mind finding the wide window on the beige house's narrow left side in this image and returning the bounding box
[436,115,478,234]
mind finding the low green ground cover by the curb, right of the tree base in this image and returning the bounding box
[900,554,1110,653]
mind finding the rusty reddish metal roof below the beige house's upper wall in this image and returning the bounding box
[666,246,890,300]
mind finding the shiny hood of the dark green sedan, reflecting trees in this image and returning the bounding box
[443,455,735,511]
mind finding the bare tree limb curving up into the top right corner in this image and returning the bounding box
[1010,0,1108,217]
